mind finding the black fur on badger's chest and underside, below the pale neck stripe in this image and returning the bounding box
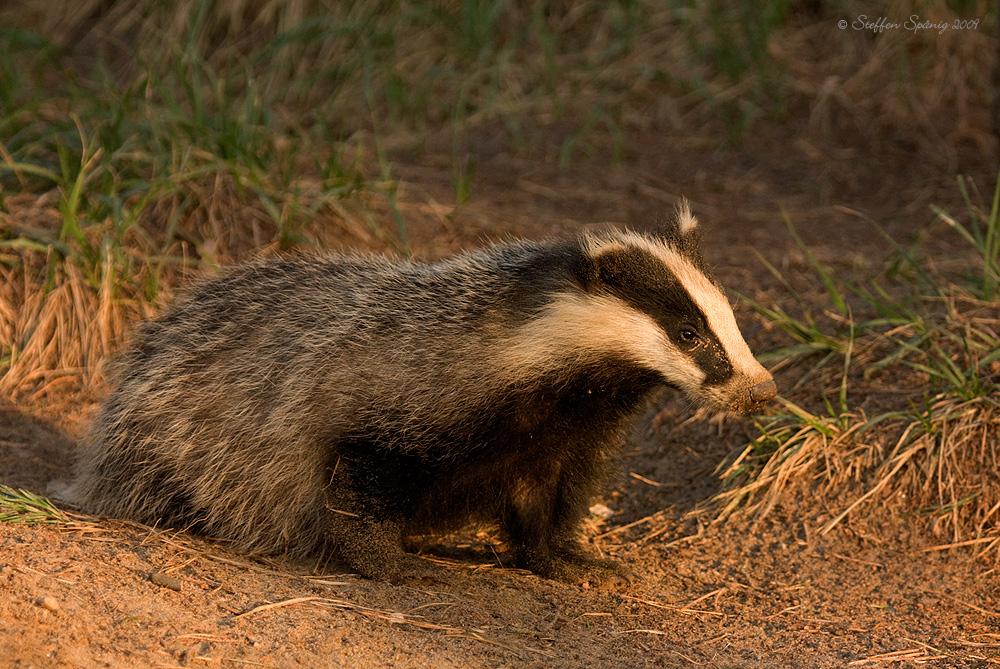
[330,358,658,533]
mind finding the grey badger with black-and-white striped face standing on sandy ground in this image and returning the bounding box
[75,206,776,587]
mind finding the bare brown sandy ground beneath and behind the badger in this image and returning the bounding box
[0,121,1000,668]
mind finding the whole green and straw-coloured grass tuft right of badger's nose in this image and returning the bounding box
[716,175,1000,558]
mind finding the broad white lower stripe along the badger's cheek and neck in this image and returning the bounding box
[502,293,705,391]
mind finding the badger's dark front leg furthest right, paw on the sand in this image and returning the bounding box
[502,456,633,589]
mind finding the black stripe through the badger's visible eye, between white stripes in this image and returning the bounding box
[597,247,734,385]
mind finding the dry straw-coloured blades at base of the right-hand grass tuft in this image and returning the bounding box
[718,396,1000,544]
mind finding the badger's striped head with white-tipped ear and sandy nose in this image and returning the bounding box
[578,203,777,412]
